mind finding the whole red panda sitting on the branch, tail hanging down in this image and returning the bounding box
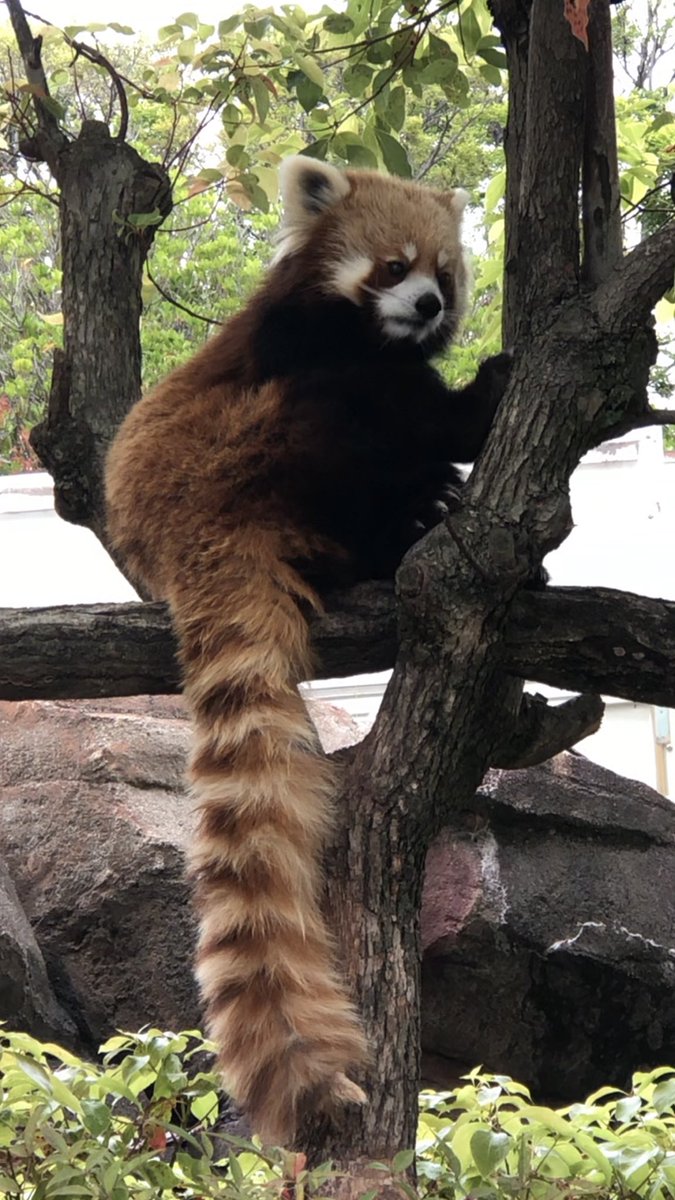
[102,156,509,1142]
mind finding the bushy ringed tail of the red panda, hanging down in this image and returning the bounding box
[172,533,366,1144]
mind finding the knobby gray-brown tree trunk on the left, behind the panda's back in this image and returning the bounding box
[7,0,172,544]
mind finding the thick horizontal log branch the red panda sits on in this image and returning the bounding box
[0,583,675,710]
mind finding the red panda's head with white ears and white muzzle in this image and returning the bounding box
[277,156,468,350]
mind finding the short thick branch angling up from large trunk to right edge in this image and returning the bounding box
[595,221,675,334]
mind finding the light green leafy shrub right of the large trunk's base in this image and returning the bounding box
[417,1067,675,1200]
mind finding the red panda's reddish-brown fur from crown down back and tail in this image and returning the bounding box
[108,159,475,1142]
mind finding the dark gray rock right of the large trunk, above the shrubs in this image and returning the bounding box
[423,754,675,1098]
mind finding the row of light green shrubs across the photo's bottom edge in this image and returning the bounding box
[0,1030,675,1200]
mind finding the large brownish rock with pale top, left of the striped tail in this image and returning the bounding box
[0,698,199,1048]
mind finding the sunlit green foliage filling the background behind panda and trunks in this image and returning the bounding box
[0,0,675,470]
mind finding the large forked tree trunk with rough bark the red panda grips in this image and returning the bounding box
[299,0,675,1180]
